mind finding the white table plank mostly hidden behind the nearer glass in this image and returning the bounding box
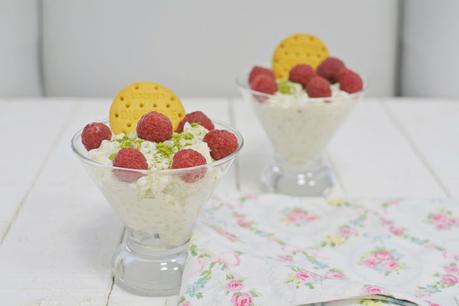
[108,98,236,306]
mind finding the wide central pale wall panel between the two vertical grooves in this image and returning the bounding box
[43,0,397,96]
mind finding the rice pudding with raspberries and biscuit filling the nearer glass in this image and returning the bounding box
[76,83,240,248]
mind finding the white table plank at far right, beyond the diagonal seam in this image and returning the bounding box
[387,99,459,197]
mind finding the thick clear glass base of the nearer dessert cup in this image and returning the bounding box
[113,229,187,296]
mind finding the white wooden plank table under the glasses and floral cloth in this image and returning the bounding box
[0,99,459,306]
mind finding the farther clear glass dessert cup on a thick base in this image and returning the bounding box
[236,75,363,196]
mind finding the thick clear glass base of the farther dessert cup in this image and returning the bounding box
[261,159,333,197]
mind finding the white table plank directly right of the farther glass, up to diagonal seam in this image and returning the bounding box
[329,100,445,197]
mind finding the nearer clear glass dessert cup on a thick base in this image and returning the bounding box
[71,123,243,296]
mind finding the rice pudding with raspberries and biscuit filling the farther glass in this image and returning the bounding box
[243,33,363,166]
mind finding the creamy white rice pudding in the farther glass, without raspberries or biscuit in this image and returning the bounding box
[253,83,357,164]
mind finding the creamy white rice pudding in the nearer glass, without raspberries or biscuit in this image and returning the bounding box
[88,123,225,246]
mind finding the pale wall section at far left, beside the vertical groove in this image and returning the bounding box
[0,0,41,97]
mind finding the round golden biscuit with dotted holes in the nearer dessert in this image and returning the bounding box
[110,82,185,134]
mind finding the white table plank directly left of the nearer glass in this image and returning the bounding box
[0,101,122,306]
